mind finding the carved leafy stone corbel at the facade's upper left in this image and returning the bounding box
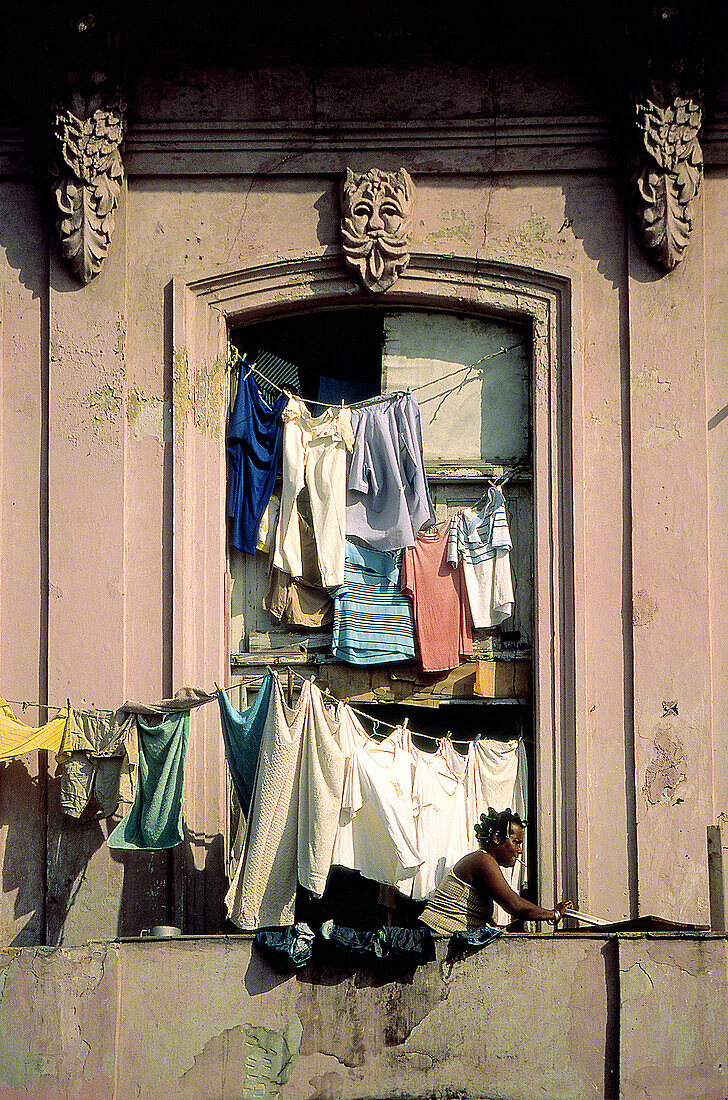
[51,14,126,283]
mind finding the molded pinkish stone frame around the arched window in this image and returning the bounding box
[168,253,587,931]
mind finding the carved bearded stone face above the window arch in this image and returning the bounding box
[341,168,415,292]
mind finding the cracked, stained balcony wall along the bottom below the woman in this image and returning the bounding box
[0,934,728,1100]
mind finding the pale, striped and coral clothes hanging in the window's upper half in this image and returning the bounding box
[231,352,514,672]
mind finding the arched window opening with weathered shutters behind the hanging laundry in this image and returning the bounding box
[230,308,538,926]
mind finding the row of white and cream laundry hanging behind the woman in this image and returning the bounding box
[227,674,525,930]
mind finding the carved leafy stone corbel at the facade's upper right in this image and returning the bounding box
[631,2,703,271]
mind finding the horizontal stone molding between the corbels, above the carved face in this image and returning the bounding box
[0,112,728,178]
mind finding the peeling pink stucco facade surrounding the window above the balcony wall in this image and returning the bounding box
[0,4,728,1098]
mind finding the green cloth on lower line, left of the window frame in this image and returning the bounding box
[108,712,189,848]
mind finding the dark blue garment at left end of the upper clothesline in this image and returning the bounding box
[228,364,288,553]
